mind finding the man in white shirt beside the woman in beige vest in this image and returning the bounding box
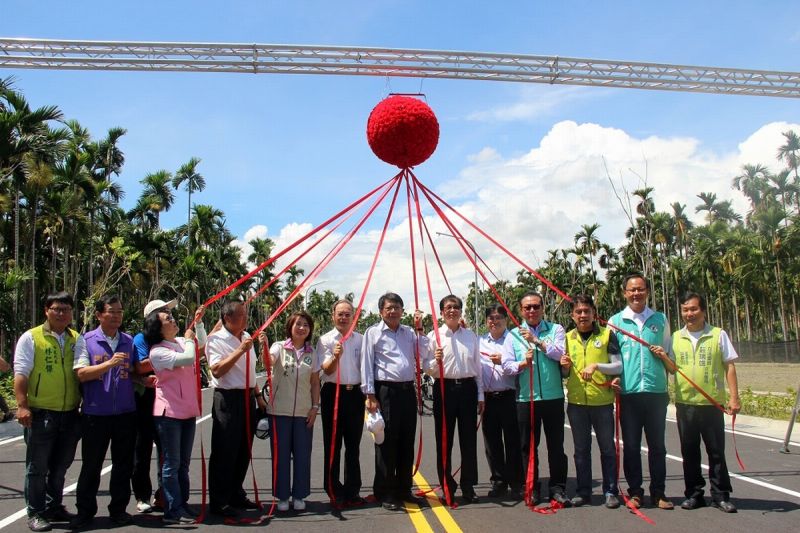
[317,300,365,506]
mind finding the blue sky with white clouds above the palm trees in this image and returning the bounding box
[0,0,800,312]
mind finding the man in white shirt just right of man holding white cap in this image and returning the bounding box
[426,294,483,503]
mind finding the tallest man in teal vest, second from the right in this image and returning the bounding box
[609,273,674,509]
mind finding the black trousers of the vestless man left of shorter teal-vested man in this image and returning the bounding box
[482,389,522,490]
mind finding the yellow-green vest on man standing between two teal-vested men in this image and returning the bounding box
[567,328,614,405]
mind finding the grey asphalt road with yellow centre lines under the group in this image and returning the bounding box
[0,382,800,533]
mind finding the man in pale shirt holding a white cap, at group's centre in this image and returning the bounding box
[361,292,428,511]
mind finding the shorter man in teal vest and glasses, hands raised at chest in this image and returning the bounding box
[502,292,570,507]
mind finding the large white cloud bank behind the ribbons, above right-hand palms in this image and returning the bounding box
[234,121,800,320]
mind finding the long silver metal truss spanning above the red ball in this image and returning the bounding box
[0,38,800,98]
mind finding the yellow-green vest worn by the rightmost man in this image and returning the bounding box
[672,324,725,405]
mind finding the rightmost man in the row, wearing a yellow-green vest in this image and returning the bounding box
[672,292,741,513]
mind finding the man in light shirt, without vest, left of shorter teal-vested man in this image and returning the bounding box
[480,304,522,500]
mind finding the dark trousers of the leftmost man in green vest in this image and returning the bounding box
[24,409,81,516]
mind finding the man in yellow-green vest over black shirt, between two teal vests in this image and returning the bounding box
[561,294,622,509]
